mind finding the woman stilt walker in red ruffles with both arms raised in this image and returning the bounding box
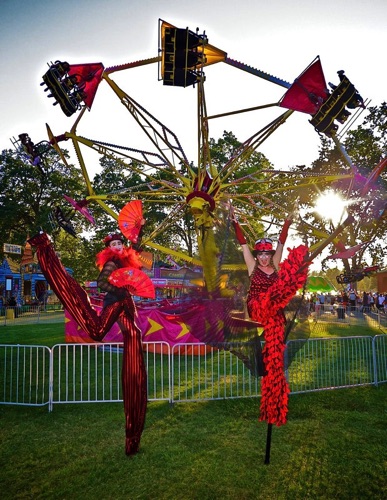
[233,213,308,463]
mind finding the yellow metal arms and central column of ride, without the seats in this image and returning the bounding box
[39,20,372,292]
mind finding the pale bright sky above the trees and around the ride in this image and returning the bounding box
[0,0,387,274]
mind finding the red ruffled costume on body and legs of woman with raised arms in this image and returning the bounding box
[247,245,308,426]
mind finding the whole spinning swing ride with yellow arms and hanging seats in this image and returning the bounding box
[12,19,386,463]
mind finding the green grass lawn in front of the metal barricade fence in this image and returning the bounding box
[0,324,387,500]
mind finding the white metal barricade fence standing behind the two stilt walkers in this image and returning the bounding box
[0,335,387,410]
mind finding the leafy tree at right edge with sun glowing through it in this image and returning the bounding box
[301,103,387,282]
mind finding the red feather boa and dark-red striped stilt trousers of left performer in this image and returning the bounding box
[29,233,147,455]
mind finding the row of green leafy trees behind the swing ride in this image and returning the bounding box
[0,103,387,281]
